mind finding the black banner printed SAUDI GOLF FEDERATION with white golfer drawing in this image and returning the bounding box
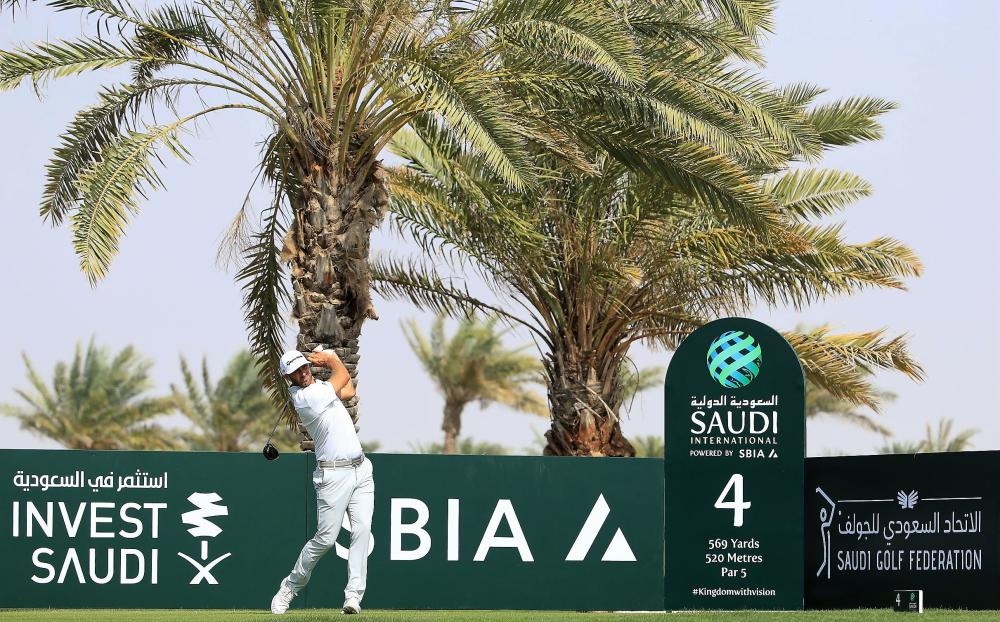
[806,451,1000,609]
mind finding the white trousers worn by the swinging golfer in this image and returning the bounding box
[285,458,375,601]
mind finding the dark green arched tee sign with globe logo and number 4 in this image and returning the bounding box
[664,318,805,610]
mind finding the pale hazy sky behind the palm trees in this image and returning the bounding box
[0,0,1000,455]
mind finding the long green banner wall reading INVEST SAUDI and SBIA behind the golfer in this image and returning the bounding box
[0,450,663,611]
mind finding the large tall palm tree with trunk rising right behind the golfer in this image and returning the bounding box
[0,0,644,428]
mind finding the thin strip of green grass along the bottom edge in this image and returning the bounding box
[0,609,998,622]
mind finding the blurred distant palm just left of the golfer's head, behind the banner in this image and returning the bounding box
[170,350,297,451]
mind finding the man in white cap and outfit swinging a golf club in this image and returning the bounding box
[271,350,375,613]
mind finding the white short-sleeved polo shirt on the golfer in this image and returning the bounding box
[289,380,361,460]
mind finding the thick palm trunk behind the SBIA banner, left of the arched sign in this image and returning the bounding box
[542,352,635,457]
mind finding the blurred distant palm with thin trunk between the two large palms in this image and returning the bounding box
[402,316,548,454]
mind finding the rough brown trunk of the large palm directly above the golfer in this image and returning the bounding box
[282,156,388,450]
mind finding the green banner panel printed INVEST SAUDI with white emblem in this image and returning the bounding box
[0,450,310,608]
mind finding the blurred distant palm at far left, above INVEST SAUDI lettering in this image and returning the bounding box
[0,340,182,450]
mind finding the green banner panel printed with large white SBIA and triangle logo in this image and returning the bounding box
[302,454,663,610]
